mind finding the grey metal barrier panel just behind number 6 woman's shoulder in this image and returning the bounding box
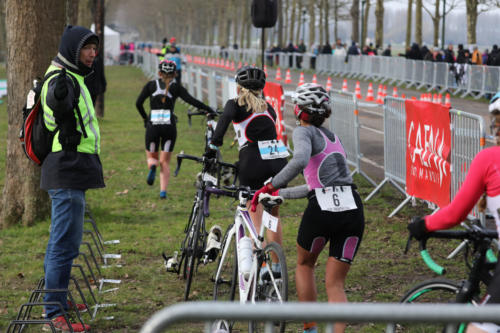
[329,90,376,186]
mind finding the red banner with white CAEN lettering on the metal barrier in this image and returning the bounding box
[405,100,451,207]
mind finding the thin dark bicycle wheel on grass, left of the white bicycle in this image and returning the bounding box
[183,209,204,301]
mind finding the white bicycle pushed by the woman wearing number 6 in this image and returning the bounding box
[213,186,288,332]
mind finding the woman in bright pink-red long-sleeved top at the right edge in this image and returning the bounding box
[408,92,500,333]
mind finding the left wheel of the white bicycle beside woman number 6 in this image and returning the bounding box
[213,224,238,301]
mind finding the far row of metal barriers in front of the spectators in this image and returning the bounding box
[174,45,500,98]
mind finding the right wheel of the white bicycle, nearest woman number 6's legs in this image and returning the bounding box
[248,242,288,333]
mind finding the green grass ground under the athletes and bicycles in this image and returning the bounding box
[0,63,470,332]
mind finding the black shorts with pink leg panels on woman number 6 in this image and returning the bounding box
[297,190,365,263]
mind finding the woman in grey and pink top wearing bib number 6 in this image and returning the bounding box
[252,83,365,333]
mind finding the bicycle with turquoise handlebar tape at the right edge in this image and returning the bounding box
[386,223,498,333]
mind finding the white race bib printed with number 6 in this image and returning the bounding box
[314,186,358,212]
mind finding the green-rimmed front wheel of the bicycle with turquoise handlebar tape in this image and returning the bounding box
[386,279,465,333]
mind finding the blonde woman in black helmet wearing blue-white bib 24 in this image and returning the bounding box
[207,66,288,269]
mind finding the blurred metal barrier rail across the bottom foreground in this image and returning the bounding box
[140,302,500,333]
